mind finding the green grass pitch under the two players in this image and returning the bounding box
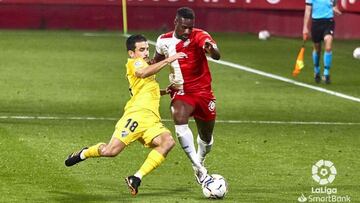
[0,30,360,203]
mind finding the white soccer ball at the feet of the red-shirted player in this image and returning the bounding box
[202,174,228,199]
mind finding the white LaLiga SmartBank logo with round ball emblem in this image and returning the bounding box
[298,160,351,202]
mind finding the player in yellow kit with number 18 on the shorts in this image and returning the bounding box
[65,35,186,195]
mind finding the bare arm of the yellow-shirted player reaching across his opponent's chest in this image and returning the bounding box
[135,52,186,78]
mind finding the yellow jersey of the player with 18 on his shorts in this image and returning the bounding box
[124,58,160,118]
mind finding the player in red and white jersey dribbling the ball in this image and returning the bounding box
[154,7,220,184]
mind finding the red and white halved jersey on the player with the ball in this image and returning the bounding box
[156,28,216,93]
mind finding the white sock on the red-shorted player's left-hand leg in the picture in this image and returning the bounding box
[175,124,201,168]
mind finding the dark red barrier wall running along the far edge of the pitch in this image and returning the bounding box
[0,0,360,38]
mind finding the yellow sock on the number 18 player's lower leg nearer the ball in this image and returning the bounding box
[135,149,165,179]
